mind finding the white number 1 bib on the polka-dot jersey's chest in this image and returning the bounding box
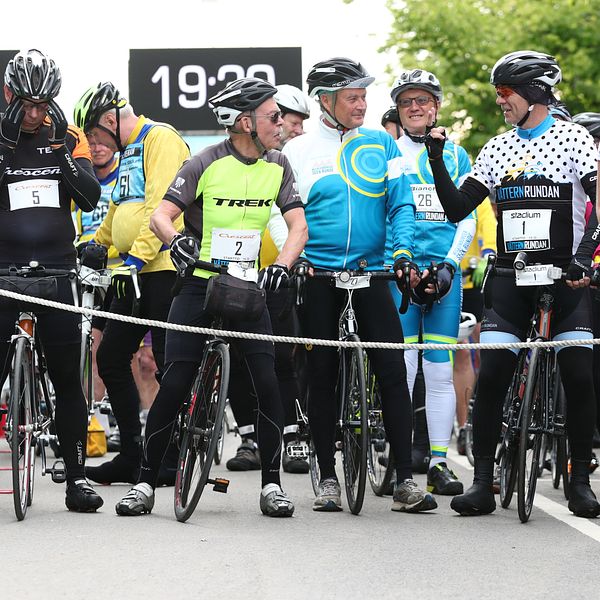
[502,208,552,252]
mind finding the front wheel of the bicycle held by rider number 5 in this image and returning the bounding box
[9,338,35,521]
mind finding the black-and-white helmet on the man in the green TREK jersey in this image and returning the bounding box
[208,77,277,127]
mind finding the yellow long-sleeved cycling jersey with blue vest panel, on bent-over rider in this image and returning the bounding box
[94,116,189,273]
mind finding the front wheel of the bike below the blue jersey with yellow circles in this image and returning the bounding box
[341,336,369,515]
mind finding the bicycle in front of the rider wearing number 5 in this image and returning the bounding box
[0,261,76,521]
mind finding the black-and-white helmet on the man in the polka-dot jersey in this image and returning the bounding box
[490,50,562,90]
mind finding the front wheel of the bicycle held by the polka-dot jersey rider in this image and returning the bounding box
[517,348,547,523]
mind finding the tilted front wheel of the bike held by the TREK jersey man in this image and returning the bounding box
[175,343,229,523]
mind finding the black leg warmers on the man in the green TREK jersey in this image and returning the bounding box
[140,354,283,487]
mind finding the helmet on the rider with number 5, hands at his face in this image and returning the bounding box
[4,49,62,101]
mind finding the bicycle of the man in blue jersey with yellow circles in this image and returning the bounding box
[296,261,410,515]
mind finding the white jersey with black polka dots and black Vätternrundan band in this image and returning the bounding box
[442,116,597,266]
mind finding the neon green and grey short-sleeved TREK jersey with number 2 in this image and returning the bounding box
[165,139,303,278]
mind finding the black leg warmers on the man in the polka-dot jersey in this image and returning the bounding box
[473,347,596,461]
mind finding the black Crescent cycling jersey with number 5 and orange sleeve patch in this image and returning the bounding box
[0,121,98,267]
